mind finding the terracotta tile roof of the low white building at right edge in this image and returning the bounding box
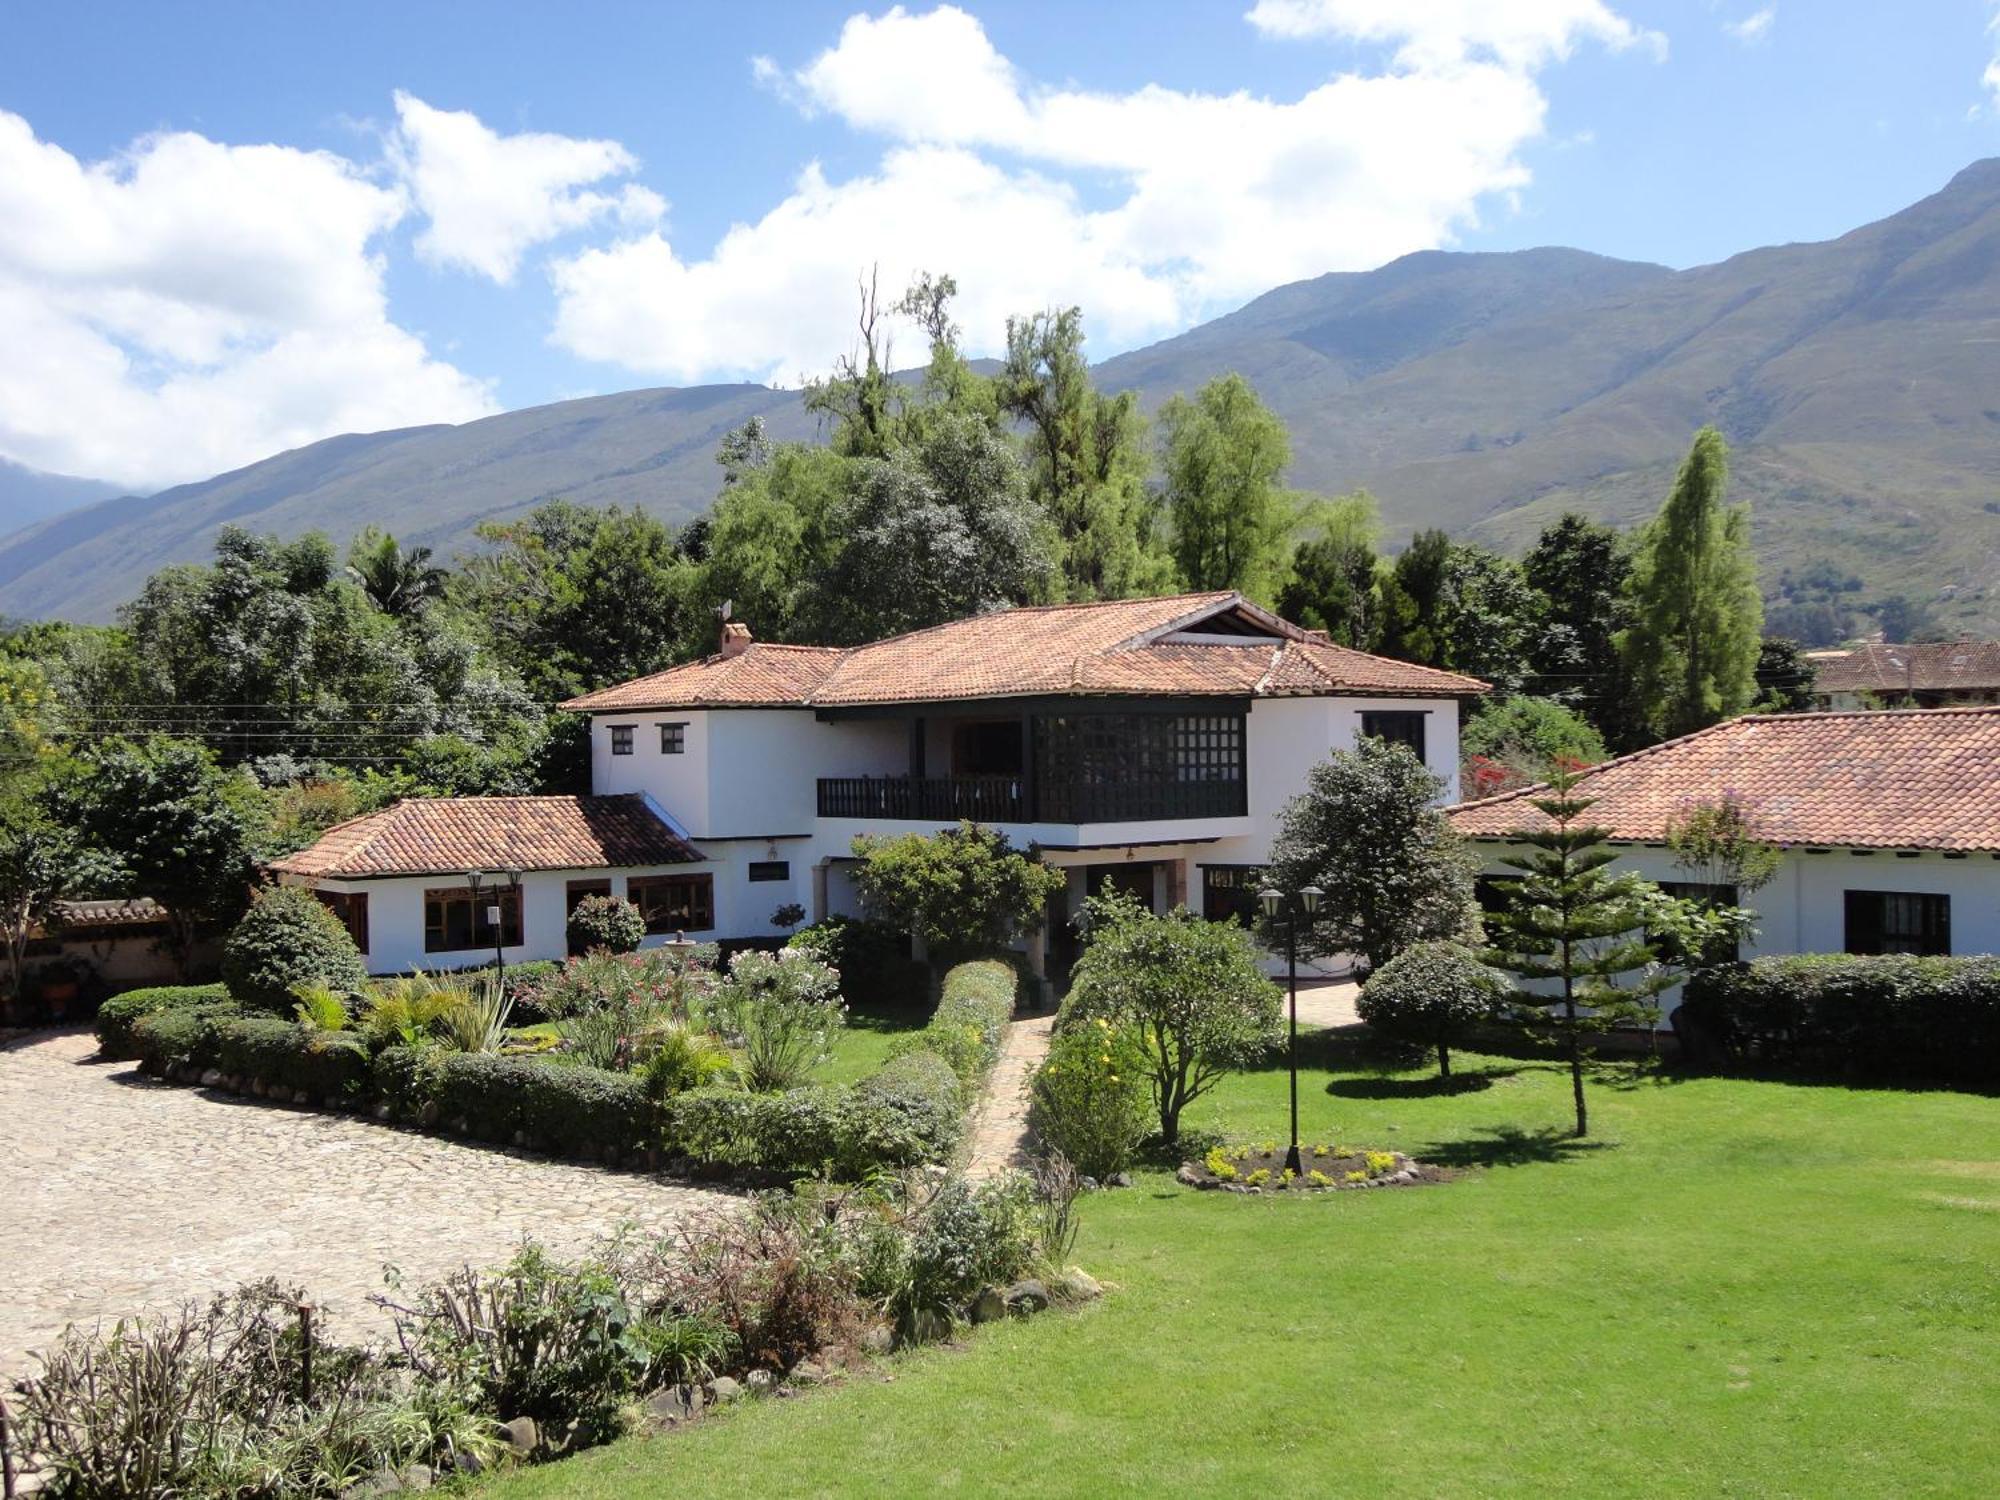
[1446,708,2000,850]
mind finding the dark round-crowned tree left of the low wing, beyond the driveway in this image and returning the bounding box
[52,736,260,974]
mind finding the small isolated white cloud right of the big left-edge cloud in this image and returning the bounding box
[390,90,666,282]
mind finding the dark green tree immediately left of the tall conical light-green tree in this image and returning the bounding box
[1522,510,1644,748]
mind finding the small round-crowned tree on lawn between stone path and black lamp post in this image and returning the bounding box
[1056,892,1278,1148]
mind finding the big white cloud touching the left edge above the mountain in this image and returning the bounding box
[0,112,494,488]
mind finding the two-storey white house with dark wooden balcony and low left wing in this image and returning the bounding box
[274,592,1486,972]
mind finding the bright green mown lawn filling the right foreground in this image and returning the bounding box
[476,1036,2000,1500]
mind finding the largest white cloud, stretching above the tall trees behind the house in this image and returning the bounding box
[552,0,1644,380]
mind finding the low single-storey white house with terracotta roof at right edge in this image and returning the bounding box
[1446,708,2000,1012]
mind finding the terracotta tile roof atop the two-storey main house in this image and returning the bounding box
[564,592,1486,712]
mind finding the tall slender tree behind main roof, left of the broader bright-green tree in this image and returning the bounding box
[994,308,1174,600]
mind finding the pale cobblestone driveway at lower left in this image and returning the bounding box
[0,1032,736,1372]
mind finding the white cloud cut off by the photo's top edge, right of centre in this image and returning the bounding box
[1246,0,1666,68]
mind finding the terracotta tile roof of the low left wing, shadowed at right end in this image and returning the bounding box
[270,794,702,880]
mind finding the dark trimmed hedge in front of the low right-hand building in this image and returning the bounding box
[1674,954,2000,1090]
